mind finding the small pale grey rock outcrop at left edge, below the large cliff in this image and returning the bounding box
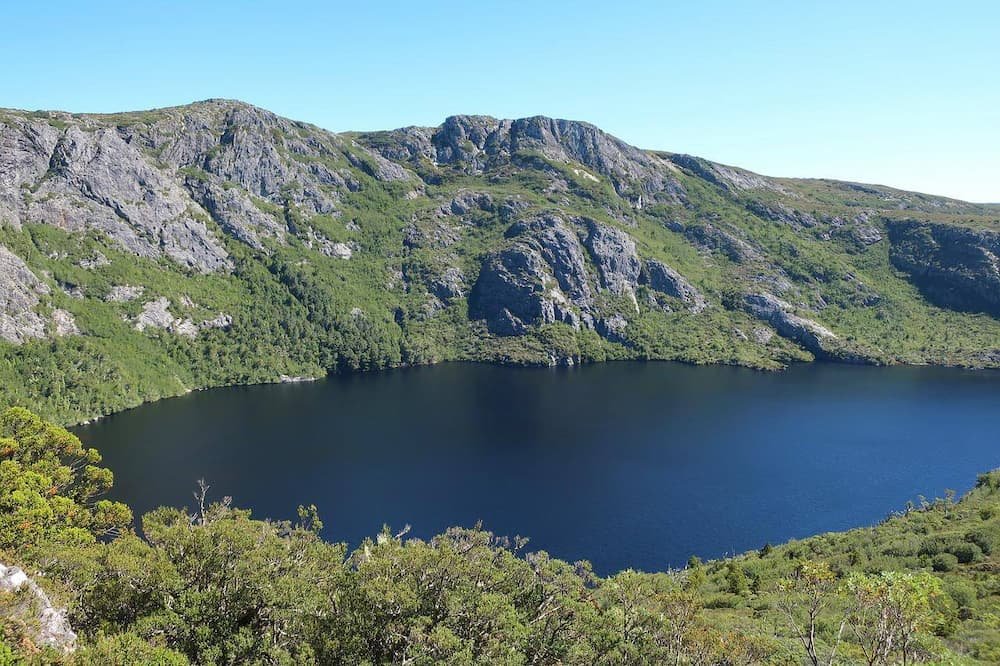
[0,245,49,344]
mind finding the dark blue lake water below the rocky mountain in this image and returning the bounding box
[77,363,1000,573]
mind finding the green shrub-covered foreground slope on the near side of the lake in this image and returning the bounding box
[0,409,1000,665]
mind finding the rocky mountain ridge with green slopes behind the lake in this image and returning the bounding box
[0,100,1000,422]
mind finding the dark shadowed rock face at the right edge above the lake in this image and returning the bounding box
[886,220,1000,316]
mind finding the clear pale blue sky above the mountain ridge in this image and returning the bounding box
[0,0,1000,201]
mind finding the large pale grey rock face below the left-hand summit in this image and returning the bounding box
[0,101,376,273]
